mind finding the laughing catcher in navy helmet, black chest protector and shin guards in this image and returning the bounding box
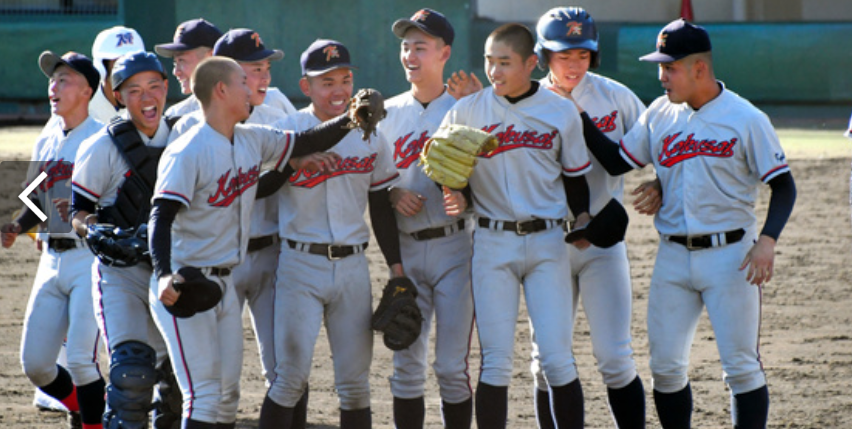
[72,51,179,428]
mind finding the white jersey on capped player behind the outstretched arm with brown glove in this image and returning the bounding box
[278,109,399,245]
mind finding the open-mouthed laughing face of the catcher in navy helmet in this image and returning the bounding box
[115,71,169,137]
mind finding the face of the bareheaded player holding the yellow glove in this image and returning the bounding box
[485,38,538,97]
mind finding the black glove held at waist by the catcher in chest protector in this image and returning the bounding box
[86,223,149,267]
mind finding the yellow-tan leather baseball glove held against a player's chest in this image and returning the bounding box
[420,124,499,189]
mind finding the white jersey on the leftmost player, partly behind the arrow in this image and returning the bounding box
[27,116,103,234]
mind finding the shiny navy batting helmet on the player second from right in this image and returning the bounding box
[535,6,601,70]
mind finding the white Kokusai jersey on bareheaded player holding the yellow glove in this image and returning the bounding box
[444,87,592,221]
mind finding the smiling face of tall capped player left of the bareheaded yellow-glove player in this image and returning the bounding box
[399,27,451,84]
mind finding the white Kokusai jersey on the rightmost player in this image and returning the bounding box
[621,82,790,235]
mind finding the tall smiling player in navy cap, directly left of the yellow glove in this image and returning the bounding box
[379,9,473,429]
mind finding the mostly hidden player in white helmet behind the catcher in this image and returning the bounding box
[89,25,145,124]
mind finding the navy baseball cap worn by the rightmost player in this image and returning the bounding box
[639,18,711,63]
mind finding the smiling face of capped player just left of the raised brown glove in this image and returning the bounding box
[299,67,353,121]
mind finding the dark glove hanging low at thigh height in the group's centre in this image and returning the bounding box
[372,277,423,351]
